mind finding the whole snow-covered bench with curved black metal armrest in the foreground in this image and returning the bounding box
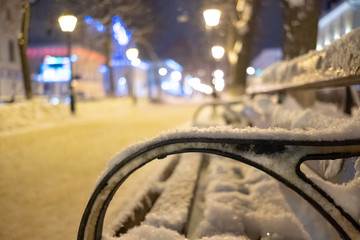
[78,31,360,240]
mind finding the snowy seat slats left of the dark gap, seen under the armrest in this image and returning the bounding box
[103,154,202,239]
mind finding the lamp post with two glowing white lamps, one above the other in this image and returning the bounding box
[203,9,224,98]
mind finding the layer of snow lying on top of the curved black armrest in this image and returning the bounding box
[107,113,360,176]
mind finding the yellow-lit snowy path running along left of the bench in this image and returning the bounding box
[0,99,195,240]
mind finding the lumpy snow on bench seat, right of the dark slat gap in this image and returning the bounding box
[198,158,310,239]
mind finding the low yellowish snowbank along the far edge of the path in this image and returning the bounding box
[0,98,194,136]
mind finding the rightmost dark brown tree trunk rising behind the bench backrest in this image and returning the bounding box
[281,0,321,60]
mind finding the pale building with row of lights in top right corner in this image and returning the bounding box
[316,0,360,50]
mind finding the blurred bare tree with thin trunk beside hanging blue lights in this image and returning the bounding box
[73,0,157,96]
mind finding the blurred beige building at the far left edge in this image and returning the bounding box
[0,0,24,101]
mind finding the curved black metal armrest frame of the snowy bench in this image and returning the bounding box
[78,134,360,240]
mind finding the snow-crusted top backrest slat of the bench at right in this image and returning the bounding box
[247,29,360,94]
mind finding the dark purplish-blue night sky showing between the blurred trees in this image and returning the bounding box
[30,0,339,74]
